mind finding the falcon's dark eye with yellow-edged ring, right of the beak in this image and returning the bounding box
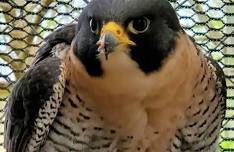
[128,17,150,34]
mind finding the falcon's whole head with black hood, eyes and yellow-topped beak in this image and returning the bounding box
[74,0,182,76]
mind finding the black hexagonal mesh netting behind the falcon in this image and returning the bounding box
[0,0,234,152]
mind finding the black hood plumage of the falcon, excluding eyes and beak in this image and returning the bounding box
[74,0,182,76]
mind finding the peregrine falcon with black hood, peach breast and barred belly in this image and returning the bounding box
[4,0,226,152]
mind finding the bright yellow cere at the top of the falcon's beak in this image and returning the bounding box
[101,21,136,45]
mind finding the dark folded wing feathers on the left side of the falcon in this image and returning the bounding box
[4,57,64,152]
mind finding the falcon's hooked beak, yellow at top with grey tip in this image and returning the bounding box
[97,22,136,60]
